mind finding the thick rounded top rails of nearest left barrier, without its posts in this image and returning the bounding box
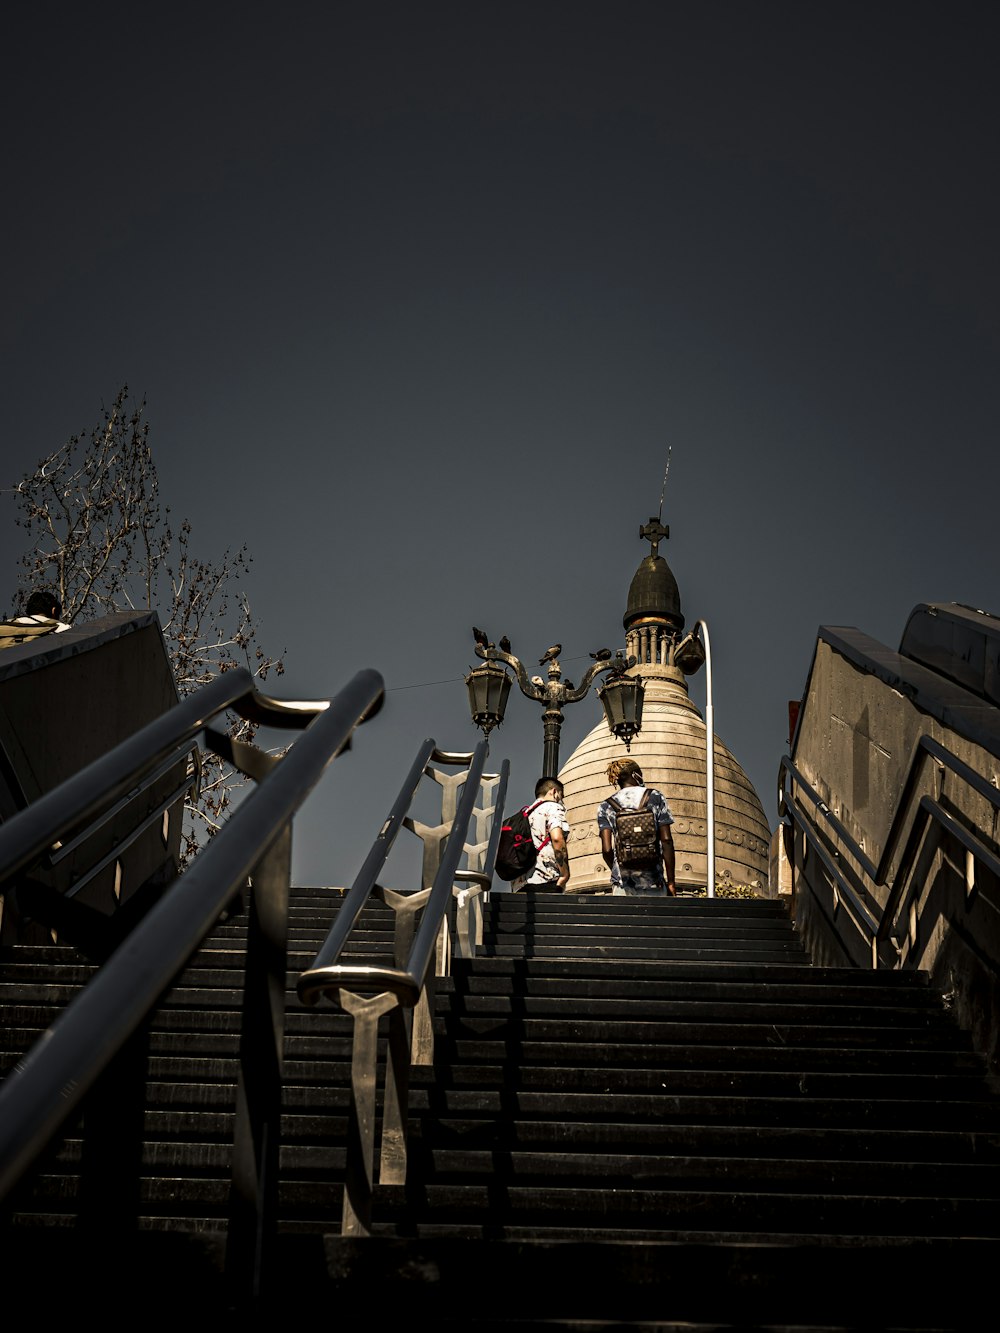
[0,669,384,1196]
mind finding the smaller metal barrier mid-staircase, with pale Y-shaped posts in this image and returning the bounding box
[297,740,509,1236]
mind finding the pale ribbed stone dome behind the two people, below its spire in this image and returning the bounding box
[560,664,771,886]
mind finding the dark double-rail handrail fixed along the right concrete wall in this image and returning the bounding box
[779,733,1000,966]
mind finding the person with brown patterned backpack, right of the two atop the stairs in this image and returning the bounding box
[597,758,677,897]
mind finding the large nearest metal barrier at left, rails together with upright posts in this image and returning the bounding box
[0,670,384,1293]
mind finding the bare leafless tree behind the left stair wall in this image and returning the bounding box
[13,385,284,860]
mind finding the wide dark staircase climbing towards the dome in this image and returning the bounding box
[0,890,1000,1329]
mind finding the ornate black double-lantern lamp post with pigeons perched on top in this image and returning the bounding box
[465,631,643,777]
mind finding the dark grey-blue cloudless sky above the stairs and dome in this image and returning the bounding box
[0,0,1000,882]
